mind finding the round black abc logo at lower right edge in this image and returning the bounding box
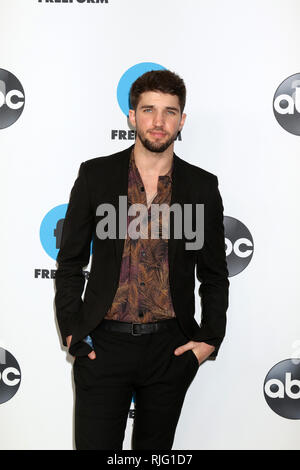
[264,359,300,419]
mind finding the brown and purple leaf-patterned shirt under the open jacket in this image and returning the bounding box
[104,152,175,323]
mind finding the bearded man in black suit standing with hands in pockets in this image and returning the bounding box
[55,70,229,450]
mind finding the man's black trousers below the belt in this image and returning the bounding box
[73,319,199,450]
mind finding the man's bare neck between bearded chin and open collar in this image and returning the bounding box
[133,139,174,176]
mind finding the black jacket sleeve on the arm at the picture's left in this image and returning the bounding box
[55,162,93,346]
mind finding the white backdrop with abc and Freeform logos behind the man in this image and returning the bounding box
[0,0,300,449]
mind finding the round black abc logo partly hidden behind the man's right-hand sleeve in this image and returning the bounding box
[224,216,254,276]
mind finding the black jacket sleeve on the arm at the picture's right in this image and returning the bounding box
[193,176,229,357]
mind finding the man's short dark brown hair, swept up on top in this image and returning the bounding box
[129,70,186,114]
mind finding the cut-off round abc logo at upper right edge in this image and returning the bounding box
[273,73,300,135]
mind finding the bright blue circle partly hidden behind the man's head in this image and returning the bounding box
[117,62,165,116]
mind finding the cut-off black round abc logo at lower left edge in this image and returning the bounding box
[0,348,21,403]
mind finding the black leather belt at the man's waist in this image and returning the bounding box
[99,318,177,336]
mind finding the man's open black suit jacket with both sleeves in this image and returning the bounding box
[55,146,229,357]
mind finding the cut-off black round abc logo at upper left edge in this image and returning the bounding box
[0,69,25,129]
